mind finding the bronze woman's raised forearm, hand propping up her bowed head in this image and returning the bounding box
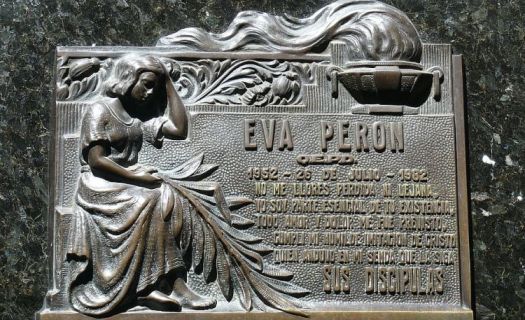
[162,76,188,140]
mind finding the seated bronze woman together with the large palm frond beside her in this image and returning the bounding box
[65,54,308,316]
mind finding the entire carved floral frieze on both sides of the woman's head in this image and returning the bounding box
[57,57,316,107]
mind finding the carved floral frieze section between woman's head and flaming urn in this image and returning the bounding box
[177,60,315,107]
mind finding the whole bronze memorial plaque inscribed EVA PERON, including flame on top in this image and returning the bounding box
[37,0,473,320]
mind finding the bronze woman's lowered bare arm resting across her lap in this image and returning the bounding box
[88,145,162,185]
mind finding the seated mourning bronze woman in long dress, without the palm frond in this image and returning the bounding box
[66,55,216,315]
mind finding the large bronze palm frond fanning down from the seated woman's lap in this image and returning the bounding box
[159,154,309,316]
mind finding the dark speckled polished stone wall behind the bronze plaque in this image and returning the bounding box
[0,0,525,319]
